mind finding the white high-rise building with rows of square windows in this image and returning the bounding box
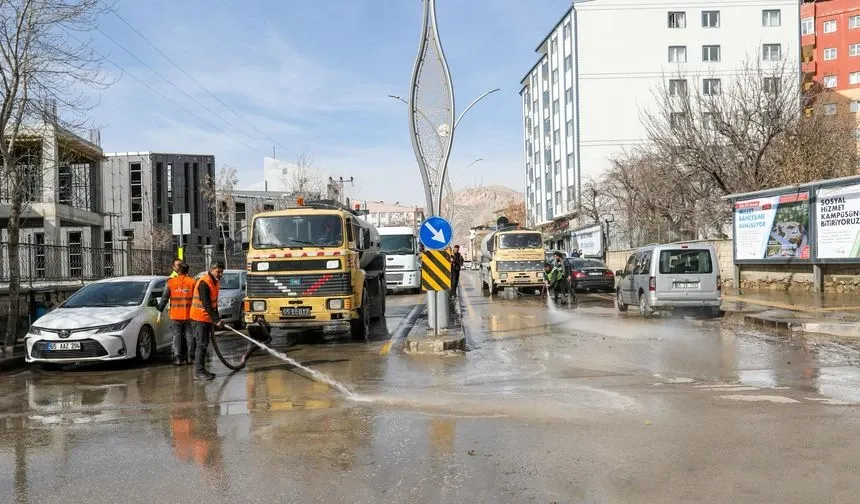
[520,0,800,231]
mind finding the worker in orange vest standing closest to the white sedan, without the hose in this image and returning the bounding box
[158,261,194,366]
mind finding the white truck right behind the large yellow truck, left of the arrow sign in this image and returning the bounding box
[378,226,421,292]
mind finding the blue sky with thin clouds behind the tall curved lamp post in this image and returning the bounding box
[92,0,569,204]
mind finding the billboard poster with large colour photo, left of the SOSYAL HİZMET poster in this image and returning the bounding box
[735,192,810,261]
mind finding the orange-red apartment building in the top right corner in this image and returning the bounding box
[800,0,860,111]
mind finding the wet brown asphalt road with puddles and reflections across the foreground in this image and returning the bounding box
[0,275,860,504]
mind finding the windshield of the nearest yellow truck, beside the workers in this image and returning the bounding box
[252,215,343,249]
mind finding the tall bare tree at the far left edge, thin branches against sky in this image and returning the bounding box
[0,0,111,348]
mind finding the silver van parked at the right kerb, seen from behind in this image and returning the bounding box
[615,242,722,317]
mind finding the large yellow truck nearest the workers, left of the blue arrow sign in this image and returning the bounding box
[244,199,385,339]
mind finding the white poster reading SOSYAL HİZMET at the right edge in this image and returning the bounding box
[815,185,860,259]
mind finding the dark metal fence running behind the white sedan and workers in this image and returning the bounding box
[0,242,245,284]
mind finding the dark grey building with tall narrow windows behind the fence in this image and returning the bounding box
[101,152,218,251]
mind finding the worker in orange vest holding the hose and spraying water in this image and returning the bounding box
[191,261,224,381]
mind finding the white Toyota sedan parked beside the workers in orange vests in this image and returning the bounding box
[25,276,171,364]
